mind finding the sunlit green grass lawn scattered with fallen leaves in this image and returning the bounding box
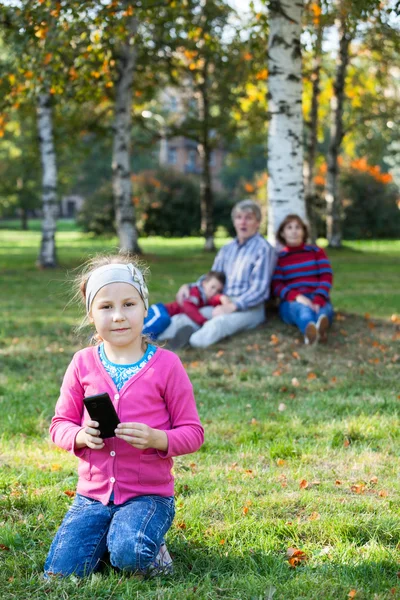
[0,230,400,600]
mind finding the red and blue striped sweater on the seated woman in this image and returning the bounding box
[272,244,332,306]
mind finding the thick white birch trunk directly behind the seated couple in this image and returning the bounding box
[268,0,306,243]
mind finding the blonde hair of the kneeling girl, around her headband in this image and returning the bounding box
[72,250,154,345]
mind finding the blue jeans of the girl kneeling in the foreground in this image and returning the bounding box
[44,494,175,577]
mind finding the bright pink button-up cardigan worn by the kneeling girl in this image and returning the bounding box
[50,347,204,504]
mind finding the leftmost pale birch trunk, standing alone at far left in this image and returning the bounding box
[37,94,58,268]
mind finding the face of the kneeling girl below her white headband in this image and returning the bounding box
[89,283,147,351]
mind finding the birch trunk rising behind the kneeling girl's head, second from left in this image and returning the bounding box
[112,17,140,253]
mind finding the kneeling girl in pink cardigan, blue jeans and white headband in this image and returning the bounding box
[45,256,204,577]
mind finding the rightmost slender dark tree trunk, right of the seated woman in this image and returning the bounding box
[325,16,352,248]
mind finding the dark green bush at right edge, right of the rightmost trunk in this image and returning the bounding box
[341,170,400,240]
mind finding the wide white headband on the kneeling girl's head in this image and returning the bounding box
[86,263,149,313]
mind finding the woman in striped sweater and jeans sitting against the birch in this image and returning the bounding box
[272,215,333,344]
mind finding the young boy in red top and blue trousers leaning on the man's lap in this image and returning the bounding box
[142,271,228,339]
